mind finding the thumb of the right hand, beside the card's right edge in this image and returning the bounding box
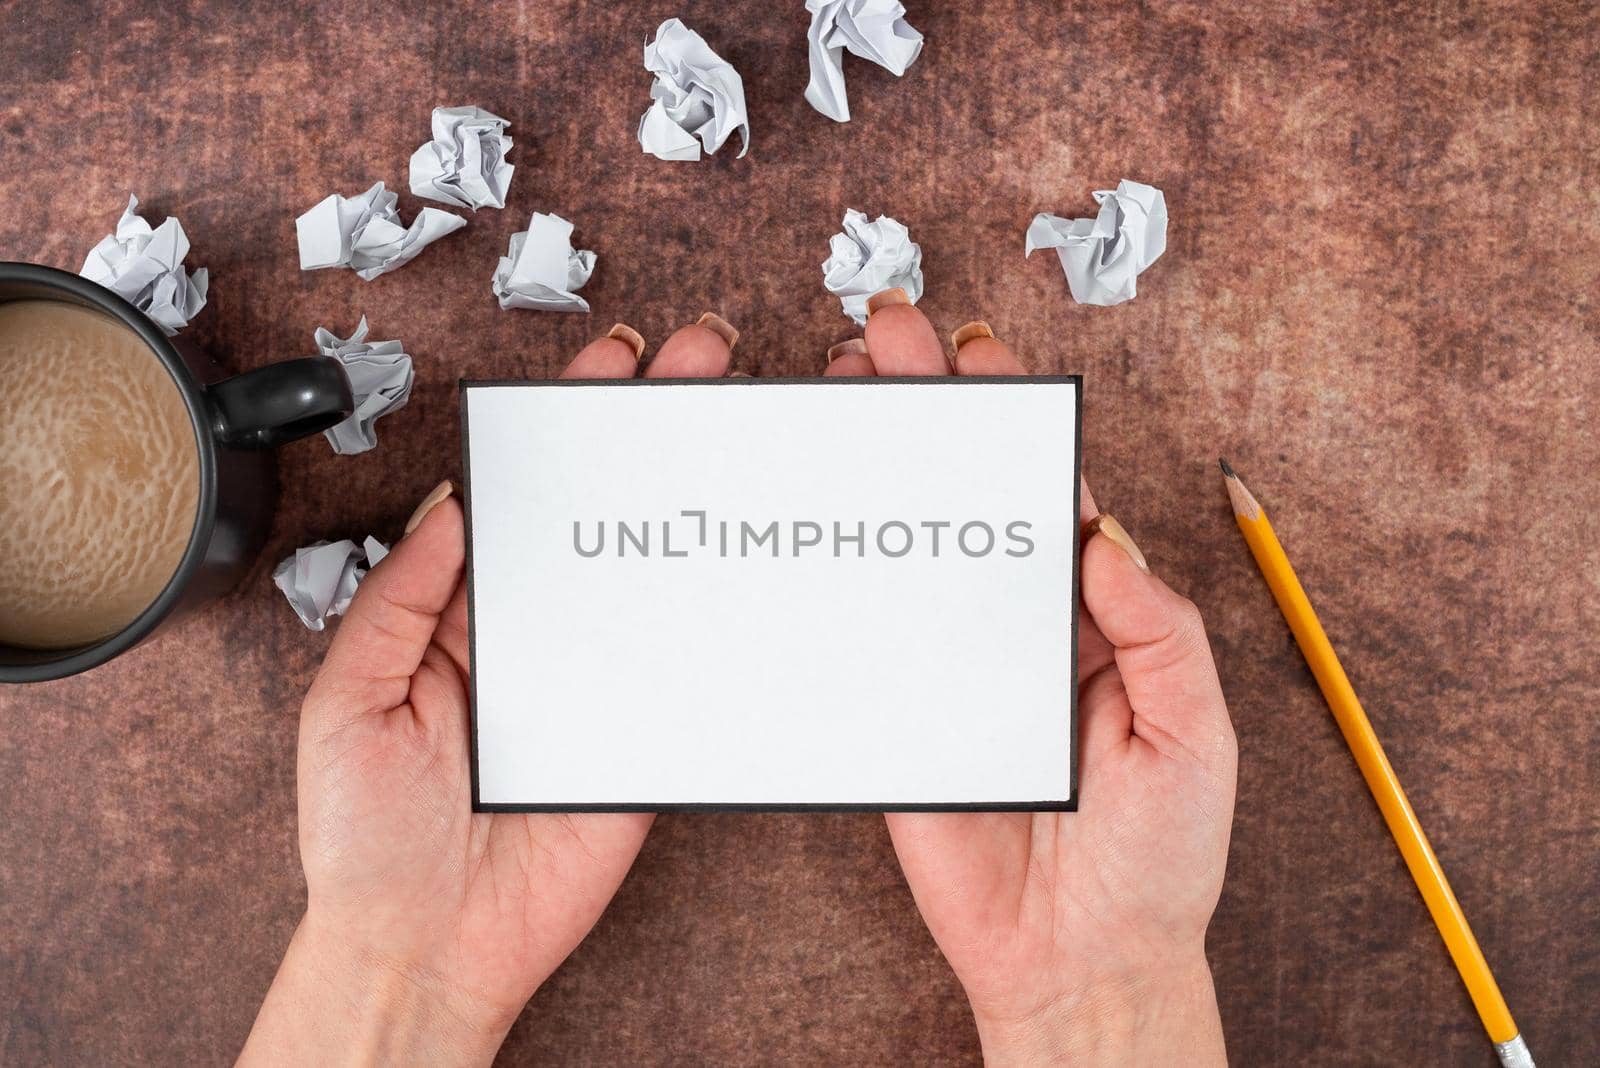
[1082,515,1235,764]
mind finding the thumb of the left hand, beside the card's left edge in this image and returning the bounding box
[306,481,466,719]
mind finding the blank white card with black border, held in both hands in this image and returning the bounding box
[462,377,1082,811]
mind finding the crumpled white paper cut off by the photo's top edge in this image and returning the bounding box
[805,0,922,123]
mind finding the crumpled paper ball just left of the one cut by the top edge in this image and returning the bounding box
[638,19,750,160]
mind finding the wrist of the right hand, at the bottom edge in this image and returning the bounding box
[974,951,1227,1068]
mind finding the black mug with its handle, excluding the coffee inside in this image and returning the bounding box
[0,262,355,683]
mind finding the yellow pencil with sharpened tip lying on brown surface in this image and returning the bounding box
[1222,460,1533,1068]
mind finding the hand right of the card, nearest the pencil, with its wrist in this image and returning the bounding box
[827,291,1237,1065]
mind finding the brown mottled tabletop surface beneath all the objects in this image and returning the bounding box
[0,0,1600,1065]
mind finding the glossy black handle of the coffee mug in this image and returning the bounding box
[206,357,355,449]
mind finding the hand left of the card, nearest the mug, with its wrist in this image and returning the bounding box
[240,318,738,1065]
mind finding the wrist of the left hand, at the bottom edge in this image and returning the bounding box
[240,913,517,1065]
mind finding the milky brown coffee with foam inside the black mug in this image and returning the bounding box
[0,301,200,649]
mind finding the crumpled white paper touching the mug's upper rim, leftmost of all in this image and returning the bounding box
[78,193,208,337]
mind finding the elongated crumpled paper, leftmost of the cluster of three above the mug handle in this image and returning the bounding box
[294,182,467,281]
